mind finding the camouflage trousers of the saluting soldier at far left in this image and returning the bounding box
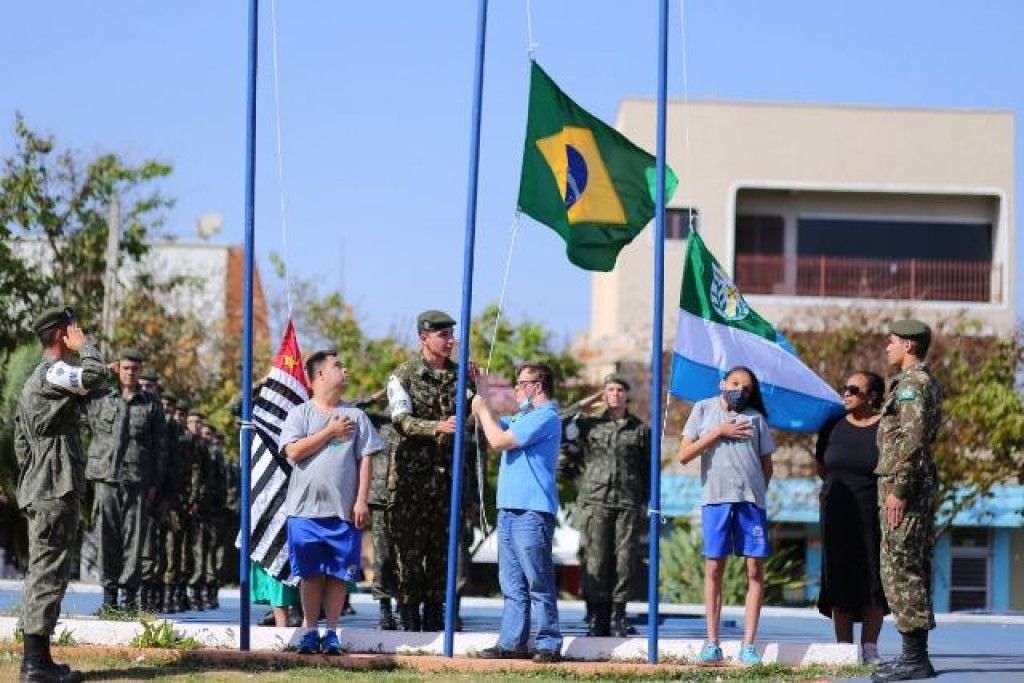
[22,494,79,637]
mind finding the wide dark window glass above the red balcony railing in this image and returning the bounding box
[794,218,992,261]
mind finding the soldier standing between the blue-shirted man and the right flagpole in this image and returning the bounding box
[563,375,650,638]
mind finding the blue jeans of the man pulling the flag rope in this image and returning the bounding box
[498,510,562,651]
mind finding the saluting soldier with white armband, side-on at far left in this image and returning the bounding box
[14,308,109,683]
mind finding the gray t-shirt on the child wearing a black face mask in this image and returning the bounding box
[683,396,775,509]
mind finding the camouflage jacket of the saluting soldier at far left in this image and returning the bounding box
[14,345,109,510]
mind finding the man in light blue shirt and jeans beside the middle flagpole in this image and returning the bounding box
[473,362,562,663]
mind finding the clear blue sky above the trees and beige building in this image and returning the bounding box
[0,0,1024,340]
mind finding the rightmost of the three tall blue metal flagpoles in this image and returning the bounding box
[647,0,669,664]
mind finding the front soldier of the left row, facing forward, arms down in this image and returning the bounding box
[85,349,167,612]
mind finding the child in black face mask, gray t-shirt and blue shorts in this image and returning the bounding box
[679,367,775,665]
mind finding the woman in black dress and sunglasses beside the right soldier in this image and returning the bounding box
[815,372,889,664]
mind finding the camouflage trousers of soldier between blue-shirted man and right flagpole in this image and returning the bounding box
[583,505,643,602]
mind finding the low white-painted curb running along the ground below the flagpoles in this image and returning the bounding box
[0,616,860,667]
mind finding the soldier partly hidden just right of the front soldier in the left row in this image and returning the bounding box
[138,370,170,612]
